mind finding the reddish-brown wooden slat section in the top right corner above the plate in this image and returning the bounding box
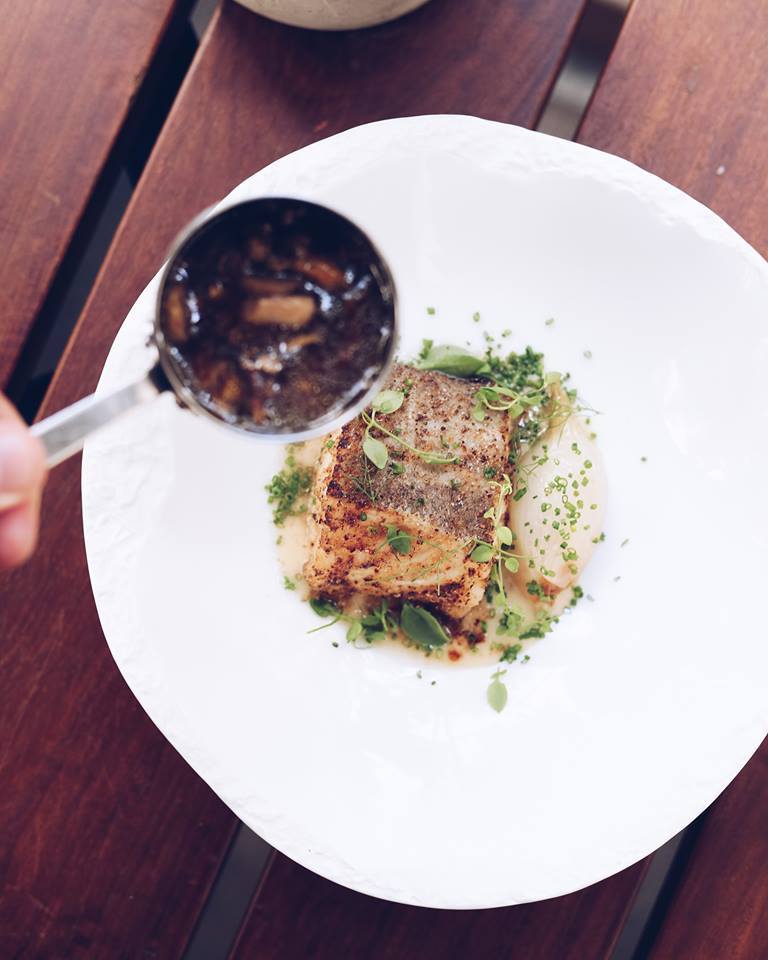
[579,0,768,255]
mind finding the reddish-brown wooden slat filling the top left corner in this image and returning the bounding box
[0,0,188,388]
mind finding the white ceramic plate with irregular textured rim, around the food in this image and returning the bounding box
[83,117,768,907]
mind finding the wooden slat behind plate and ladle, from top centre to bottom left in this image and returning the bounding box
[0,0,600,960]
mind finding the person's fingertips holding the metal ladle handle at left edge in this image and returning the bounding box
[0,394,46,570]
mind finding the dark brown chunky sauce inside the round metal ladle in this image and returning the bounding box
[160,199,394,433]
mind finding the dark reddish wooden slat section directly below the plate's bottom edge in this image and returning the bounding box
[230,853,642,960]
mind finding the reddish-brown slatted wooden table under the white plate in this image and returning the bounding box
[0,0,768,960]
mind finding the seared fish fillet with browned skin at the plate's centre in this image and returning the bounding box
[304,365,510,618]
